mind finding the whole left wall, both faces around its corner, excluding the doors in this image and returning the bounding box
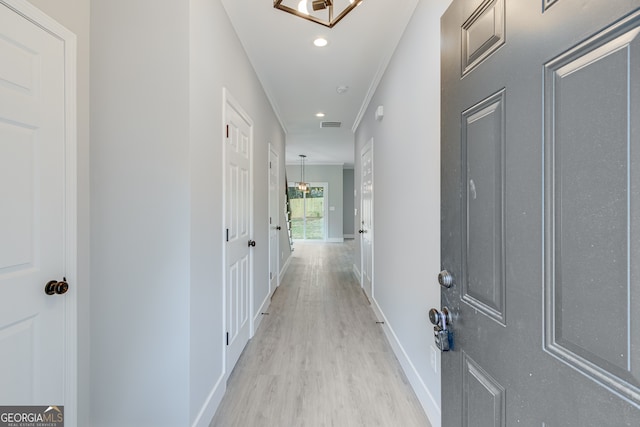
[89,0,284,427]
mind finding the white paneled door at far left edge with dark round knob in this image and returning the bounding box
[0,1,76,414]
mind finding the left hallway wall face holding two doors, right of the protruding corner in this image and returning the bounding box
[190,0,289,426]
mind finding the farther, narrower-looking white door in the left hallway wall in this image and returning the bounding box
[269,148,282,293]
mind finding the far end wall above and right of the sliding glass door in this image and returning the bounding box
[287,164,343,242]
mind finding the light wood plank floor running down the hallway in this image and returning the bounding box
[210,242,430,427]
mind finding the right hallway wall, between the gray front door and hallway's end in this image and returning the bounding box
[354,0,449,427]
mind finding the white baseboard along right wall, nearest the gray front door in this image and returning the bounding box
[368,298,442,427]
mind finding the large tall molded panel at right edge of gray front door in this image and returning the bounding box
[544,13,640,404]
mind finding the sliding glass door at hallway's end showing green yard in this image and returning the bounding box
[288,182,329,241]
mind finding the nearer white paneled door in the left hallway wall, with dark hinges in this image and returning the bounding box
[225,96,252,374]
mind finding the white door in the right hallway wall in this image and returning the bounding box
[358,140,373,298]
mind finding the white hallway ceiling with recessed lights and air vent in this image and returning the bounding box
[221,0,419,167]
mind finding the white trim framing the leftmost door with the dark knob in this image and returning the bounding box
[0,0,79,427]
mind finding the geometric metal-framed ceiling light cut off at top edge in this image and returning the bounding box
[273,0,363,28]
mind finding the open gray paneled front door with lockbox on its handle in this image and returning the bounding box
[441,0,640,427]
